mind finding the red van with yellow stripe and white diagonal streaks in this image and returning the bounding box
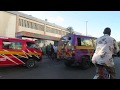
[0,37,42,68]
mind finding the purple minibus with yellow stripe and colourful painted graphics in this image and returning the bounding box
[57,34,97,69]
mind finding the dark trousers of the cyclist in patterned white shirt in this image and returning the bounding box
[95,64,116,79]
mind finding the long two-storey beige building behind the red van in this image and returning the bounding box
[0,11,69,46]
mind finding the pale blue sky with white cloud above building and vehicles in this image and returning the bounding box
[20,11,120,41]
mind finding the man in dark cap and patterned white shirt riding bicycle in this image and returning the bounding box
[92,27,119,79]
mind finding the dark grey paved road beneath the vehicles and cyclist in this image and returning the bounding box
[0,57,120,79]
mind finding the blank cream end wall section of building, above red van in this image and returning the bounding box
[0,11,16,37]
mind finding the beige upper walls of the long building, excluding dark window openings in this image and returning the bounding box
[0,11,68,43]
